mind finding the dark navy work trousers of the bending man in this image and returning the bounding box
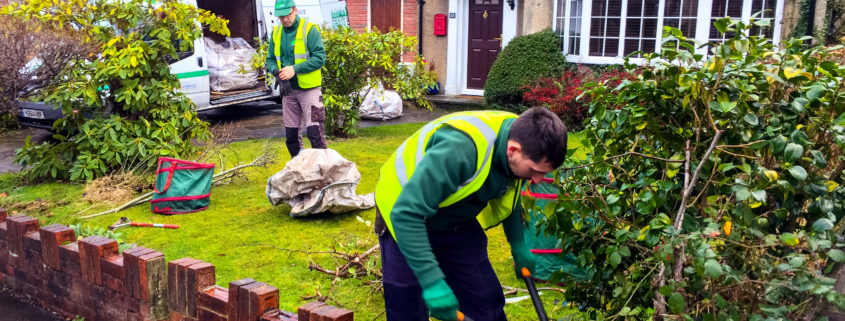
[379,216,507,321]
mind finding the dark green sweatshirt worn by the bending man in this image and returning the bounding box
[390,119,523,288]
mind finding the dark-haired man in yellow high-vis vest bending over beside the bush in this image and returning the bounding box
[375,107,566,321]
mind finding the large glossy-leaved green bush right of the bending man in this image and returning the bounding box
[539,19,845,320]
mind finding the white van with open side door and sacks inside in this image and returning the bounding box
[18,0,346,129]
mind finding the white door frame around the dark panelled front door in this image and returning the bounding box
[445,0,518,96]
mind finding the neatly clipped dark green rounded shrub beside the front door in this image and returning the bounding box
[484,29,566,111]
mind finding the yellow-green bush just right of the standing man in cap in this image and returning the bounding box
[322,27,434,137]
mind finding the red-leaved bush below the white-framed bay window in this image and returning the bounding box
[522,70,633,131]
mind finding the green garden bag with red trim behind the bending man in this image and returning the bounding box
[522,174,588,280]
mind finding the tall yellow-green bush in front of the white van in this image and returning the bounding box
[5,0,229,181]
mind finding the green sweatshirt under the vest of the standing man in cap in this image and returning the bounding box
[267,15,326,89]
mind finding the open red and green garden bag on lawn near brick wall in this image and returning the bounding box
[150,157,214,215]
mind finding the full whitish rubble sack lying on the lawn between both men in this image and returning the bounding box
[265,148,376,216]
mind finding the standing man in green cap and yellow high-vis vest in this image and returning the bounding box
[267,0,326,158]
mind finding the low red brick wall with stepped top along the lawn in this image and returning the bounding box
[0,209,353,321]
